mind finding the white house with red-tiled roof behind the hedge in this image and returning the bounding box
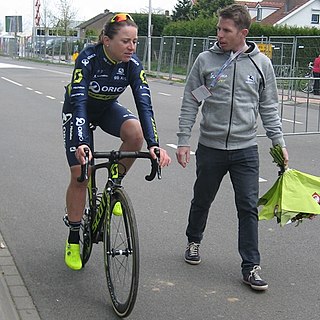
[237,0,320,29]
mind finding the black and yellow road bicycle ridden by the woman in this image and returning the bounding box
[74,136,161,317]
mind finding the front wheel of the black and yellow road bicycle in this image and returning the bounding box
[103,188,139,317]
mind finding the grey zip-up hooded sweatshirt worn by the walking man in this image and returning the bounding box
[177,42,285,150]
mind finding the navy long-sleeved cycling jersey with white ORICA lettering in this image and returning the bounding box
[66,44,159,148]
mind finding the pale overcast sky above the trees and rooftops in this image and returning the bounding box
[0,0,178,33]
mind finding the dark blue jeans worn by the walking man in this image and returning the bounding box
[186,144,260,274]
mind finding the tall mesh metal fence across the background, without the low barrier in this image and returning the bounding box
[0,36,320,80]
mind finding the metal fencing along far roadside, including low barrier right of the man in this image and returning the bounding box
[0,36,320,134]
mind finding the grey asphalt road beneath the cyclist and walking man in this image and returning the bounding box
[0,57,320,320]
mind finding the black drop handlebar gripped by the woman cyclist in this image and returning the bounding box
[77,148,161,182]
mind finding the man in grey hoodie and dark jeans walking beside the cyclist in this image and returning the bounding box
[176,4,288,290]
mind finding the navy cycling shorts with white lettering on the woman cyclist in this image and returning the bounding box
[62,100,138,167]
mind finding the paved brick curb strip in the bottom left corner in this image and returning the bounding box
[0,233,41,320]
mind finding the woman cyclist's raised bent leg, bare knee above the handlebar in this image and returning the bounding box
[98,101,143,174]
